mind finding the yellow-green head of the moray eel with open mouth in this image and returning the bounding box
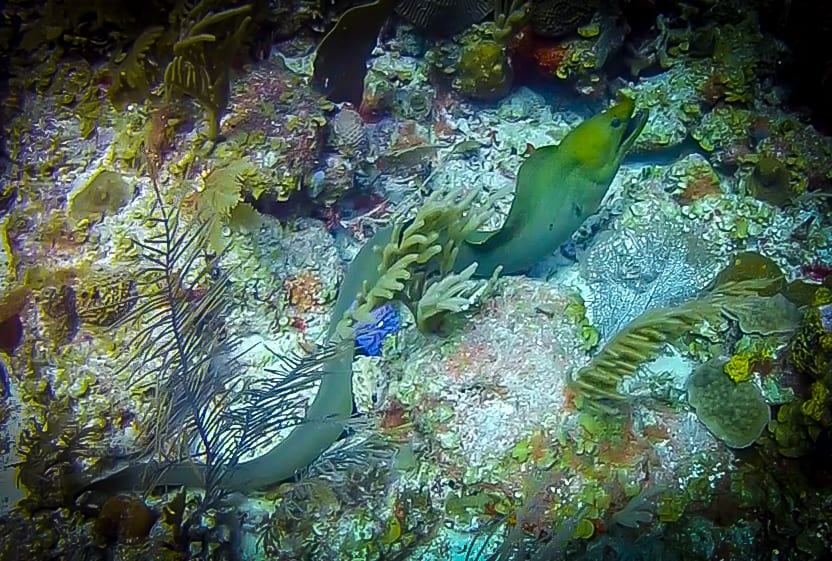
[559,97,647,179]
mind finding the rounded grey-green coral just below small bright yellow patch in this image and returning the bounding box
[688,359,771,448]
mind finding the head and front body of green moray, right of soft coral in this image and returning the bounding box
[458,98,647,276]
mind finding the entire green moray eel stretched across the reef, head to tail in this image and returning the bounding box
[78,98,647,491]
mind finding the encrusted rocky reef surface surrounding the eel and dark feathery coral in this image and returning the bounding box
[0,0,832,560]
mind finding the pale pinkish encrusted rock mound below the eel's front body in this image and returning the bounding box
[388,279,582,474]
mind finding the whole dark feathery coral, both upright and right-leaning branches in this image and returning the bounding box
[109,182,342,498]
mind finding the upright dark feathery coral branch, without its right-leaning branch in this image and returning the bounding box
[121,179,245,494]
